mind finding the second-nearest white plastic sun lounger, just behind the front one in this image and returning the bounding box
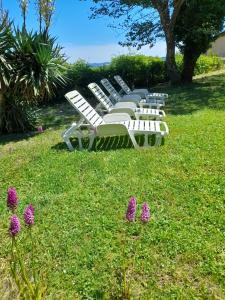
[88,83,165,120]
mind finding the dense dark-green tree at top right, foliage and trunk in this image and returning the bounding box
[175,0,225,82]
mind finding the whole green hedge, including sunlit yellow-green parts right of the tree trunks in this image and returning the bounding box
[53,55,224,102]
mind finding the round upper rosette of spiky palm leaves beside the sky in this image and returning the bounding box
[11,30,65,103]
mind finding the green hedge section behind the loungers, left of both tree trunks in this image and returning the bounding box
[57,55,166,105]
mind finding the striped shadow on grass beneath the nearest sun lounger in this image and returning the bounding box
[52,135,164,152]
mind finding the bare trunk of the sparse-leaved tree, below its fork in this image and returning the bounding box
[166,32,181,85]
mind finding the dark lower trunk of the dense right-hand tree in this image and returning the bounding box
[181,53,199,83]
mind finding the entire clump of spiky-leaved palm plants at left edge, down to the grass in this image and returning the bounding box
[0,23,66,132]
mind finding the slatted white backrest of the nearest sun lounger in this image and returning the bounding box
[65,91,105,127]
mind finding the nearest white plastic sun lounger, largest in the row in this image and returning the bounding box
[62,91,169,150]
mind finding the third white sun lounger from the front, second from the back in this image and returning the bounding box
[101,78,165,109]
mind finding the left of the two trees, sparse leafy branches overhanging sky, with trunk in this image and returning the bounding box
[87,0,185,83]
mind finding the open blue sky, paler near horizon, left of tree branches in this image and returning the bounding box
[3,0,165,63]
